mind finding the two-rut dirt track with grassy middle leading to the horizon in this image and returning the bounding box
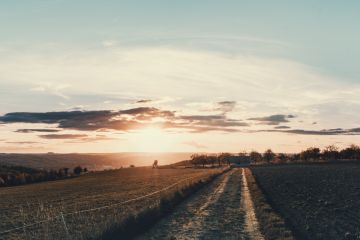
[138,169,263,240]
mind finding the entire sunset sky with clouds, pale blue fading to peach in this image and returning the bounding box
[0,0,360,152]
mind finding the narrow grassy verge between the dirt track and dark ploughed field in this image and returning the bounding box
[245,168,295,240]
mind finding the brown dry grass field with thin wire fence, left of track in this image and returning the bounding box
[0,168,219,239]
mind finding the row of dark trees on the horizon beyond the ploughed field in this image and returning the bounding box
[190,144,360,167]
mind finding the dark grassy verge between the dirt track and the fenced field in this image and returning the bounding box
[101,169,228,240]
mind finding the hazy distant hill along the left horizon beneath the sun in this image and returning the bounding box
[0,153,191,170]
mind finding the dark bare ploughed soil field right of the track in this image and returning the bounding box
[252,163,360,240]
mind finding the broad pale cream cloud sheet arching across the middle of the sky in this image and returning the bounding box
[0,46,360,124]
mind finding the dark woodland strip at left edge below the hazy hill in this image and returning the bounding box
[0,165,88,187]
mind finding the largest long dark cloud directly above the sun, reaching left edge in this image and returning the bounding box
[0,107,248,133]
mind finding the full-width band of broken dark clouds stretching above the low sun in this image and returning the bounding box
[0,108,360,136]
